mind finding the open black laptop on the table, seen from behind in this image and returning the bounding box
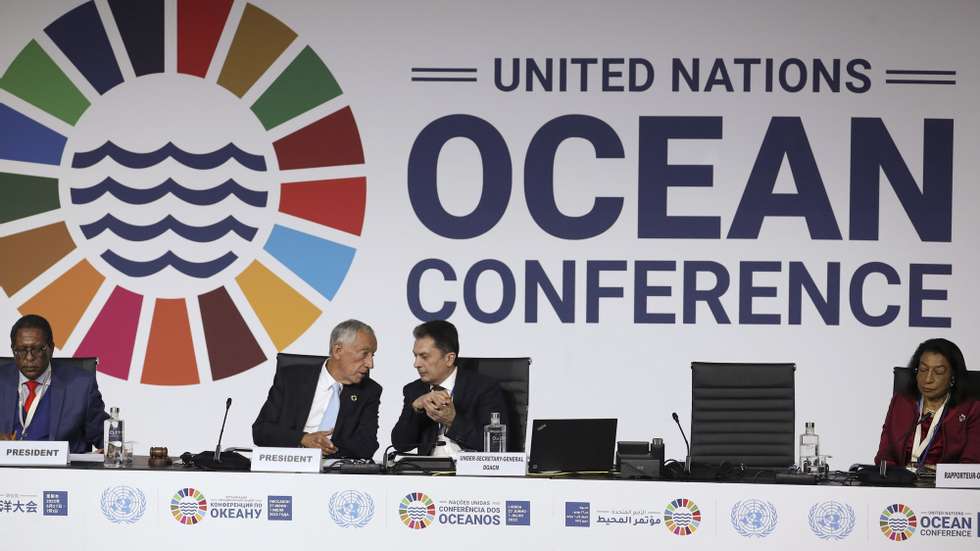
[528,419,617,473]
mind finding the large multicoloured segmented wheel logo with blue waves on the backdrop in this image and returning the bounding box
[0,0,367,385]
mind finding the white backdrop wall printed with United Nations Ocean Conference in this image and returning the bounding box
[0,0,980,467]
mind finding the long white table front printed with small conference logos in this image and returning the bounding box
[0,458,980,551]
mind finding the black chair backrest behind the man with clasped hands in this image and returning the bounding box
[456,358,531,452]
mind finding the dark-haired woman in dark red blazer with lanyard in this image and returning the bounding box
[875,339,980,469]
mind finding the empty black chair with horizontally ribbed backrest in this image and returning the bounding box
[691,362,796,467]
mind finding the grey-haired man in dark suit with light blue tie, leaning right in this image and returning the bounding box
[252,320,381,459]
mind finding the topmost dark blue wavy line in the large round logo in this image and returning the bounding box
[71,141,265,172]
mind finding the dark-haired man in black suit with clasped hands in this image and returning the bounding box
[391,320,507,455]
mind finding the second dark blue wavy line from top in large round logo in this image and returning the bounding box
[71,178,269,207]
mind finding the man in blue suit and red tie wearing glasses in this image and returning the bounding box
[0,314,109,453]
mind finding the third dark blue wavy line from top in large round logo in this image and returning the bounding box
[81,214,258,243]
